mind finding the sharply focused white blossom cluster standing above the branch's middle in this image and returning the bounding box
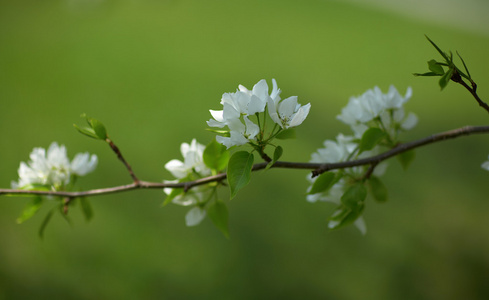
[207,79,311,148]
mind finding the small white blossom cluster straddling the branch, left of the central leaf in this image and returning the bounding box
[163,139,212,226]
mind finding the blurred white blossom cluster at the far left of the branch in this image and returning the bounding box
[12,142,98,190]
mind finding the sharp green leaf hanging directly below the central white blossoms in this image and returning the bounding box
[227,151,255,199]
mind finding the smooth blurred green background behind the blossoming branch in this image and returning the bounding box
[0,0,489,299]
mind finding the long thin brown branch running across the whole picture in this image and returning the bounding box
[0,126,489,199]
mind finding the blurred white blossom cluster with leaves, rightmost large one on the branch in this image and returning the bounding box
[307,86,417,233]
